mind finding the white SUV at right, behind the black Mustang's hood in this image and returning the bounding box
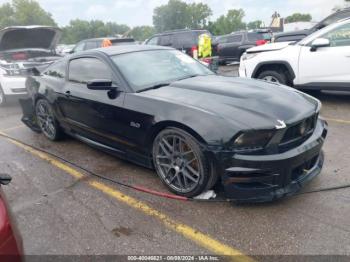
[239,19,350,91]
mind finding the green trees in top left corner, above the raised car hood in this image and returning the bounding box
[0,0,56,28]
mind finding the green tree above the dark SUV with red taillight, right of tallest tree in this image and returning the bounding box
[208,9,246,35]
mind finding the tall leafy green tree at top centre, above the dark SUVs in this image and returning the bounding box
[153,0,212,32]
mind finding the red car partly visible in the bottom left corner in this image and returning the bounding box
[0,174,23,262]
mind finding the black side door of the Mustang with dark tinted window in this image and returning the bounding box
[60,57,128,152]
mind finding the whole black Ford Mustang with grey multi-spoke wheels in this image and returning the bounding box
[22,46,327,201]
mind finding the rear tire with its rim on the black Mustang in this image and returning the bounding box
[35,99,63,141]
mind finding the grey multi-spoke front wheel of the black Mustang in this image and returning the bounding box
[153,133,204,194]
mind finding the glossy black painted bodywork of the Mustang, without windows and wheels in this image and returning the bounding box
[22,47,327,201]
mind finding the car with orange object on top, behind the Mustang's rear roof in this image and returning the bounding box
[70,37,136,53]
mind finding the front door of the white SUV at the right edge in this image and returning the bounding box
[298,23,350,89]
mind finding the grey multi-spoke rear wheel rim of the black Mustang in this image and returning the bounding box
[36,100,57,140]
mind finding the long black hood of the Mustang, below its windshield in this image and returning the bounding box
[143,75,319,129]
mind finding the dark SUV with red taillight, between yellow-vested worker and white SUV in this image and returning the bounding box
[213,30,272,64]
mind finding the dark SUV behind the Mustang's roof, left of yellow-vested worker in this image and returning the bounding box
[145,29,211,57]
